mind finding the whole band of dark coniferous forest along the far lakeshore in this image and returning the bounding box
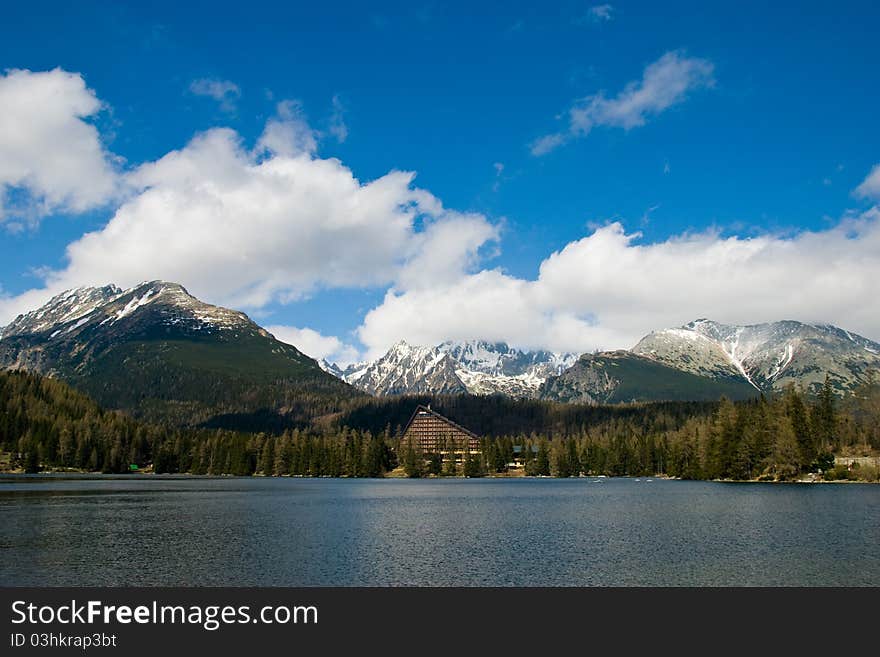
[0,372,880,481]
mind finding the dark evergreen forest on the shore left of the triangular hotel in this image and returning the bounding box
[0,372,396,477]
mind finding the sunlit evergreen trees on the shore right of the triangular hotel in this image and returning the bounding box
[370,381,880,481]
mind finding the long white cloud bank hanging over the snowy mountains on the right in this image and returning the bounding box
[358,207,880,357]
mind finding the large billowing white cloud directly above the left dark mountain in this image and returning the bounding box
[0,110,495,325]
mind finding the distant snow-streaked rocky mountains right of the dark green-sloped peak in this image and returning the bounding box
[324,319,880,403]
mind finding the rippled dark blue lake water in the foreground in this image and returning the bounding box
[0,476,880,586]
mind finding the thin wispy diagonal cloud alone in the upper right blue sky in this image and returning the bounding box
[531,51,714,156]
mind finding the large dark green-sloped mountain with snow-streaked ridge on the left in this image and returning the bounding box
[0,281,361,429]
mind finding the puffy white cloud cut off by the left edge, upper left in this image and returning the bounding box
[0,68,119,224]
